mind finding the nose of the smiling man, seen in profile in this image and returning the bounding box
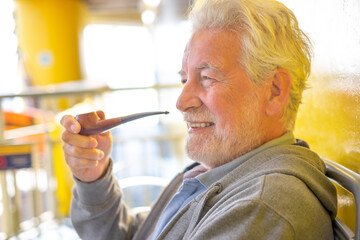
[176,80,202,112]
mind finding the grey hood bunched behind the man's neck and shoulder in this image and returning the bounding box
[220,140,337,219]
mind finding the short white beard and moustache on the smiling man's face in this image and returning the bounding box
[184,94,262,168]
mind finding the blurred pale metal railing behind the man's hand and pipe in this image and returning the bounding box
[0,83,183,239]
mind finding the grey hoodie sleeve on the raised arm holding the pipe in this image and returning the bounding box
[70,159,144,240]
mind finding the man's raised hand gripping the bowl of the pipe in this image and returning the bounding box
[60,111,112,182]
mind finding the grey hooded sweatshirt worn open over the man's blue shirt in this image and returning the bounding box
[71,144,337,240]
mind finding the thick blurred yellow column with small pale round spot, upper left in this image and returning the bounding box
[15,0,82,86]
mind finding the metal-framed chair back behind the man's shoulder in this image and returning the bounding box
[322,158,360,240]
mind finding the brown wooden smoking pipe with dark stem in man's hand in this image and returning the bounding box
[75,111,169,136]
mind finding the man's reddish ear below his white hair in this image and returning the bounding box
[266,68,291,116]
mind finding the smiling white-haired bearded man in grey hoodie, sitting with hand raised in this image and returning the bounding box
[61,0,336,240]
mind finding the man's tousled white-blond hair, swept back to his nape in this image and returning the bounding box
[189,0,311,130]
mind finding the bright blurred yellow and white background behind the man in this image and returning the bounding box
[0,0,360,239]
